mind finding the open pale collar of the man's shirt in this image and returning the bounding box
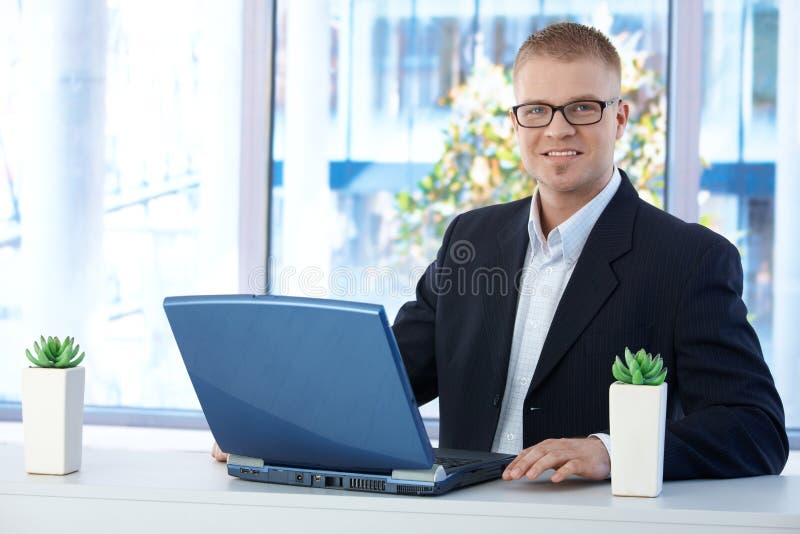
[528,167,622,265]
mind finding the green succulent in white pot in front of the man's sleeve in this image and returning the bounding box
[608,347,667,497]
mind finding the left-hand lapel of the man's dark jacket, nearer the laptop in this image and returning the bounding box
[482,199,530,385]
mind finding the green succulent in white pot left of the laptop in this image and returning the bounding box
[22,336,85,475]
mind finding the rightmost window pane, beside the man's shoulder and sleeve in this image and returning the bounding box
[698,0,800,428]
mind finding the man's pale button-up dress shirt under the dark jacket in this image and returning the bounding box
[492,167,621,454]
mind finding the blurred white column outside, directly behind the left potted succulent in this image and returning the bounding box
[19,0,106,362]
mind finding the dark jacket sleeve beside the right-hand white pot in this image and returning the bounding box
[664,240,789,479]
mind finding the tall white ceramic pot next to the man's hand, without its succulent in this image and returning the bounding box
[608,382,667,497]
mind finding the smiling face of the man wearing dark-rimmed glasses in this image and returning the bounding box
[511,56,628,204]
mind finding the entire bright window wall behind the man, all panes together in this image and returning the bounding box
[0,0,800,440]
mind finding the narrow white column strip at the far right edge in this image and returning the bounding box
[772,0,800,427]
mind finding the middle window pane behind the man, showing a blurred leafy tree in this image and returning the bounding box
[268,0,667,417]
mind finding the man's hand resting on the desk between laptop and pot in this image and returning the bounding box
[503,436,611,482]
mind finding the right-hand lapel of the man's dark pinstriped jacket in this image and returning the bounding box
[528,175,639,392]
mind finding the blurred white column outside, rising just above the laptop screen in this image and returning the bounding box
[282,0,333,297]
